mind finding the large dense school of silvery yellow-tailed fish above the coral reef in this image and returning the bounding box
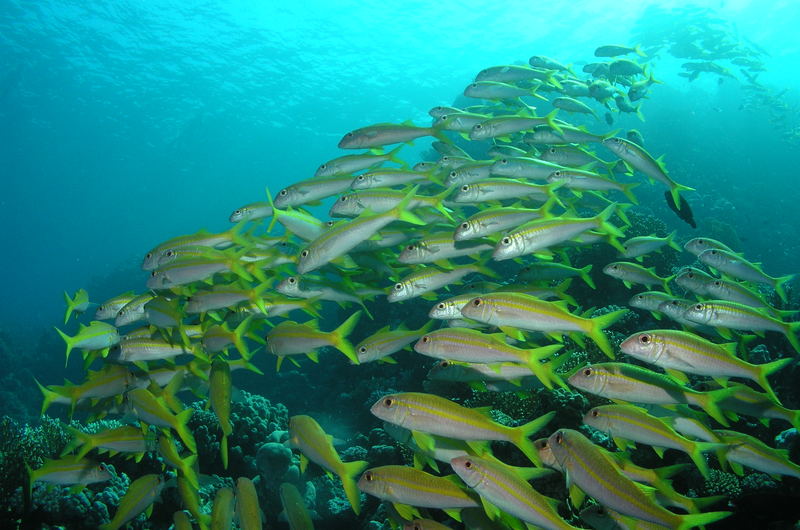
[39,41,800,529]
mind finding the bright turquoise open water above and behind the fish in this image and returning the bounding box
[0,0,800,524]
